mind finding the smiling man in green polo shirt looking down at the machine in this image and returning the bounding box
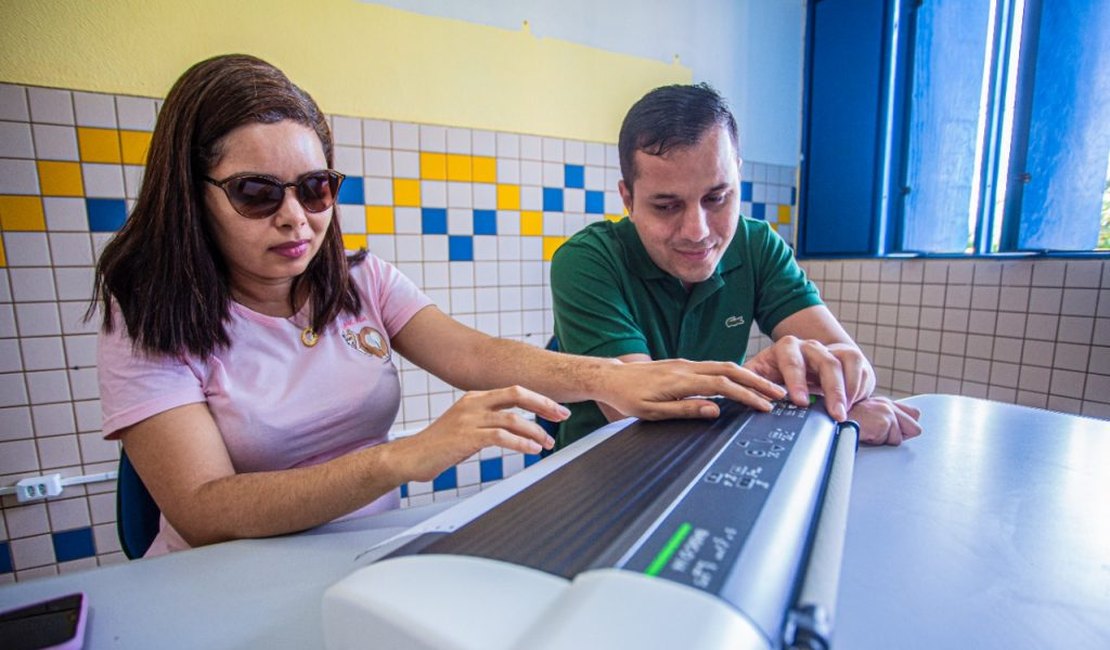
[552,84,921,446]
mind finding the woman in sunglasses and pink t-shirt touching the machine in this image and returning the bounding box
[93,55,783,555]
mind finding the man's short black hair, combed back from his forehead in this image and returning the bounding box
[617,83,740,190]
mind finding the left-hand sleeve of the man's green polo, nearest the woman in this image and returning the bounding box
[551,235,650,357]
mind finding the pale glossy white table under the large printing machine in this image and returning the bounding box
[0,395,1110,650]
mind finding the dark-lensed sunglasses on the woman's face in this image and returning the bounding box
[204,170,345,219]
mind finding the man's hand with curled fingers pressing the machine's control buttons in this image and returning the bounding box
[744,335,875,422]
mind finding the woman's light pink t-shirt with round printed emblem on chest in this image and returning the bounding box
[97,255,432,557]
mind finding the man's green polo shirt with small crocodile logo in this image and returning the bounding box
[551,217,821,447]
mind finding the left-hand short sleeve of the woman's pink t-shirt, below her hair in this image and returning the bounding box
[97,314,206,439]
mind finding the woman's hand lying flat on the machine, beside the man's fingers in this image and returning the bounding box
[596,359,786,419]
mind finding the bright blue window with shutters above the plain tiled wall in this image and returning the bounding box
[798,0,1110,256]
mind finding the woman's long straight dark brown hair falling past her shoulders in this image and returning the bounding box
[85,54,365,358]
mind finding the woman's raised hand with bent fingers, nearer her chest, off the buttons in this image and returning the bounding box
[383,386,571,484]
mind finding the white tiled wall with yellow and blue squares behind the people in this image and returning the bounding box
[0,78,795,583]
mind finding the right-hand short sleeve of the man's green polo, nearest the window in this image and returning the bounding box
[748,222,823,335]
